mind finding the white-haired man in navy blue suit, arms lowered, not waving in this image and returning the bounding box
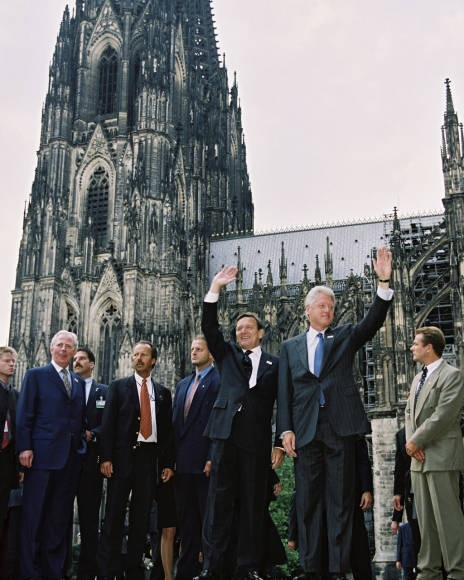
[16,330,85,580]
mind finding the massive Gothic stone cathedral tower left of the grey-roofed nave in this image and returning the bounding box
[10,0,253,387]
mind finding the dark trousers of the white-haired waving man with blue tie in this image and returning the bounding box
[294,408,356,573]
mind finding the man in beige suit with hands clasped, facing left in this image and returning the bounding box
[405,326,464,580]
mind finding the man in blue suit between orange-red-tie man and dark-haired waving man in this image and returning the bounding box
[172,336,220,580]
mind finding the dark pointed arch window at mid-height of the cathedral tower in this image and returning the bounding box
[87,166,110,248]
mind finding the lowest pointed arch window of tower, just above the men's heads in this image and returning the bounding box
[99,303,122,384]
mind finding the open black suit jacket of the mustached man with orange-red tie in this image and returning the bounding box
[100,375,174,477]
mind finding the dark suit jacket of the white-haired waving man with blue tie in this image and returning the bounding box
[277,296,391,448]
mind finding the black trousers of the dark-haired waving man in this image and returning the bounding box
[203,441,270,573]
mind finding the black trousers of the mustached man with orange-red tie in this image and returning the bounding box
[97,443,157,580]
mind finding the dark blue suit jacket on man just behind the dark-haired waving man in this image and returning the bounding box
[172,367,220,473]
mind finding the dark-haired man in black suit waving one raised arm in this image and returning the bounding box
[196,266,283,579]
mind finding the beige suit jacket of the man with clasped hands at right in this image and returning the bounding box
[405,361,464,472]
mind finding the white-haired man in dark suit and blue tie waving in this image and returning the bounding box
[277,248,393,579]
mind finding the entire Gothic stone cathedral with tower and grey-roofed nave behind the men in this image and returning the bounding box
[10,0,464,574]
